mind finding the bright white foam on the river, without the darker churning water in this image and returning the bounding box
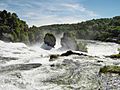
[0,41,120,90]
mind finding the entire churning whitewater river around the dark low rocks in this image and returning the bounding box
[0,40,120,90]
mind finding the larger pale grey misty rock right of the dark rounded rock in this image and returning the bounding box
[61,33,78,50]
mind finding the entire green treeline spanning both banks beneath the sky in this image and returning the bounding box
[0,10,120,44]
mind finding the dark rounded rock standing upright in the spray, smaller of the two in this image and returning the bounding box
[44,33,56,47]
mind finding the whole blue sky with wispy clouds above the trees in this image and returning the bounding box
[0,0,120,26]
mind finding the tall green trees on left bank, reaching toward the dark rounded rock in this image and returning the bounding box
[0,10,41,44]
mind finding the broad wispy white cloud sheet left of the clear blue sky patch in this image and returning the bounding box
[0,0,98,26]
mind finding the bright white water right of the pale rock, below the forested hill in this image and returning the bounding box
[87,41,120,56]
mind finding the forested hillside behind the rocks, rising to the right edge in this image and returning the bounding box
[40,16,120,43]
